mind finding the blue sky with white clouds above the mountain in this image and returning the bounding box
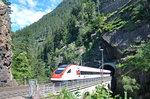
[9,0,63,31]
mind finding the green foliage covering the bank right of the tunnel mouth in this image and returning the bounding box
[117,41,150,97]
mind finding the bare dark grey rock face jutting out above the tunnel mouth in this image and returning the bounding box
[103,24,150,50]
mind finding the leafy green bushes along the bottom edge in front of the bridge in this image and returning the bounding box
[47,85,119,99]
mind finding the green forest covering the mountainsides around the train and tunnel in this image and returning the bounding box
[10,0,150,98]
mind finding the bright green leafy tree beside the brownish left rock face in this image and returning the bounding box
[12,31,32,80]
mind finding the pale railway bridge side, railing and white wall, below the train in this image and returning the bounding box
[35,77,112,97]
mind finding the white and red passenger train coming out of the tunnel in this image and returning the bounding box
[51,64,111,82]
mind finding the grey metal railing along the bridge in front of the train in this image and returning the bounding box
[39,77,112,97]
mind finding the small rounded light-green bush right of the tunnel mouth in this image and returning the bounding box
[122,76,140,92]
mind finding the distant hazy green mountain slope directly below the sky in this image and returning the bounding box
[16,0,76,40]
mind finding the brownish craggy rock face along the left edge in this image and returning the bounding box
[0,1,16,87]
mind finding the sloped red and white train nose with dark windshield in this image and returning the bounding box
[51,65,68,82]
